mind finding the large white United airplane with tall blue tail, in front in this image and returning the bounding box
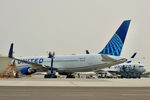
[8,20,130,78]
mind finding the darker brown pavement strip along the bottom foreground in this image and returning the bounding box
[0,86,150,100]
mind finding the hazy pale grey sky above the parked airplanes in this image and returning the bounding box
[0,0,150,70]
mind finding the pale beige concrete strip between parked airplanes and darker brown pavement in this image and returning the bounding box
[0,75,150,87]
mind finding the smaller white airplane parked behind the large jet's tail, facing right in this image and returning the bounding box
[96,53,146,78]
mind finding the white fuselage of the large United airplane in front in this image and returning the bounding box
[15,54,126,72]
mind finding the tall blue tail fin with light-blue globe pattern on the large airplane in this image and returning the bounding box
[99,20,131,56]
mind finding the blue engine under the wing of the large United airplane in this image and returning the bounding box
[20,66,36,75]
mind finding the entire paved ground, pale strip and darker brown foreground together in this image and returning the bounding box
[0,76,150,100]
